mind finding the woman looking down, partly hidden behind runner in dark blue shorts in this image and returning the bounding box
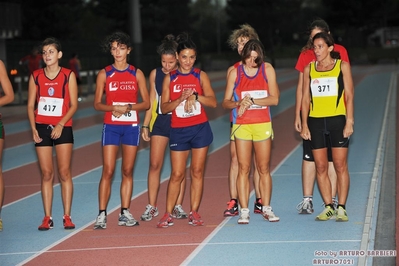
[141,34,188,221]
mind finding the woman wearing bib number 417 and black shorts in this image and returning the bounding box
[27,38,78,231]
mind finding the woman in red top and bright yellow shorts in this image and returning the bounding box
[222,40,280,224]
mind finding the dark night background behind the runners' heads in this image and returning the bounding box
[0,0,399,75]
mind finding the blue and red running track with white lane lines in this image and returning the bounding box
[0,65,399,265]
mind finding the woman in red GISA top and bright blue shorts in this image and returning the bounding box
[94,32,150,229]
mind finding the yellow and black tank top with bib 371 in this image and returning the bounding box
[309,59,346,117]
